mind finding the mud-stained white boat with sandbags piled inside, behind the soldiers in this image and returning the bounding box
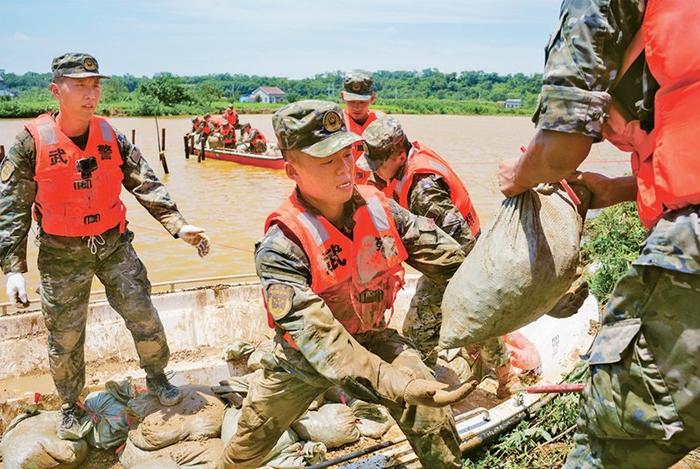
[0,275,599,468]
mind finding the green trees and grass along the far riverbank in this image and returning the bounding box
[0,69,542,118]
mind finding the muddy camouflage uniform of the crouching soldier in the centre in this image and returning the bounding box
[219,99,464,469]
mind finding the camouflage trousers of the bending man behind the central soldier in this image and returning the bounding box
[401,276,510,379]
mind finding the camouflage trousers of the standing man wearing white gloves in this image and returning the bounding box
[38,228,170,403]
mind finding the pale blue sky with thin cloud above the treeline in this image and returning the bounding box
[0,0,561,78]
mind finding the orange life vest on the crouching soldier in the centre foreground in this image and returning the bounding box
[265,186,408,334]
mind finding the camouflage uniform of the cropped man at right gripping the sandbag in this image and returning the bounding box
[534,0,700,468]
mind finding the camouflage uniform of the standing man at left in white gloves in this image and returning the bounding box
[0,122,186,403]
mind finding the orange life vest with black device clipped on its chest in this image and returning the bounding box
[26,114,126,237]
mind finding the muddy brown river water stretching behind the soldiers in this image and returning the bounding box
[0,115,629,301]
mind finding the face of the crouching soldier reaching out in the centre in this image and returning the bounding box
[285,146,355,207]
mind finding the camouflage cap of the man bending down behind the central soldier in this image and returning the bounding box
[357,116,406,171]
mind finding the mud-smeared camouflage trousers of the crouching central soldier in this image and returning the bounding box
[218,329,462,469]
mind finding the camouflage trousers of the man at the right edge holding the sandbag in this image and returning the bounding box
[565,265,700,469]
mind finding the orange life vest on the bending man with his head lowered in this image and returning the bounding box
[385,142,481,236]
